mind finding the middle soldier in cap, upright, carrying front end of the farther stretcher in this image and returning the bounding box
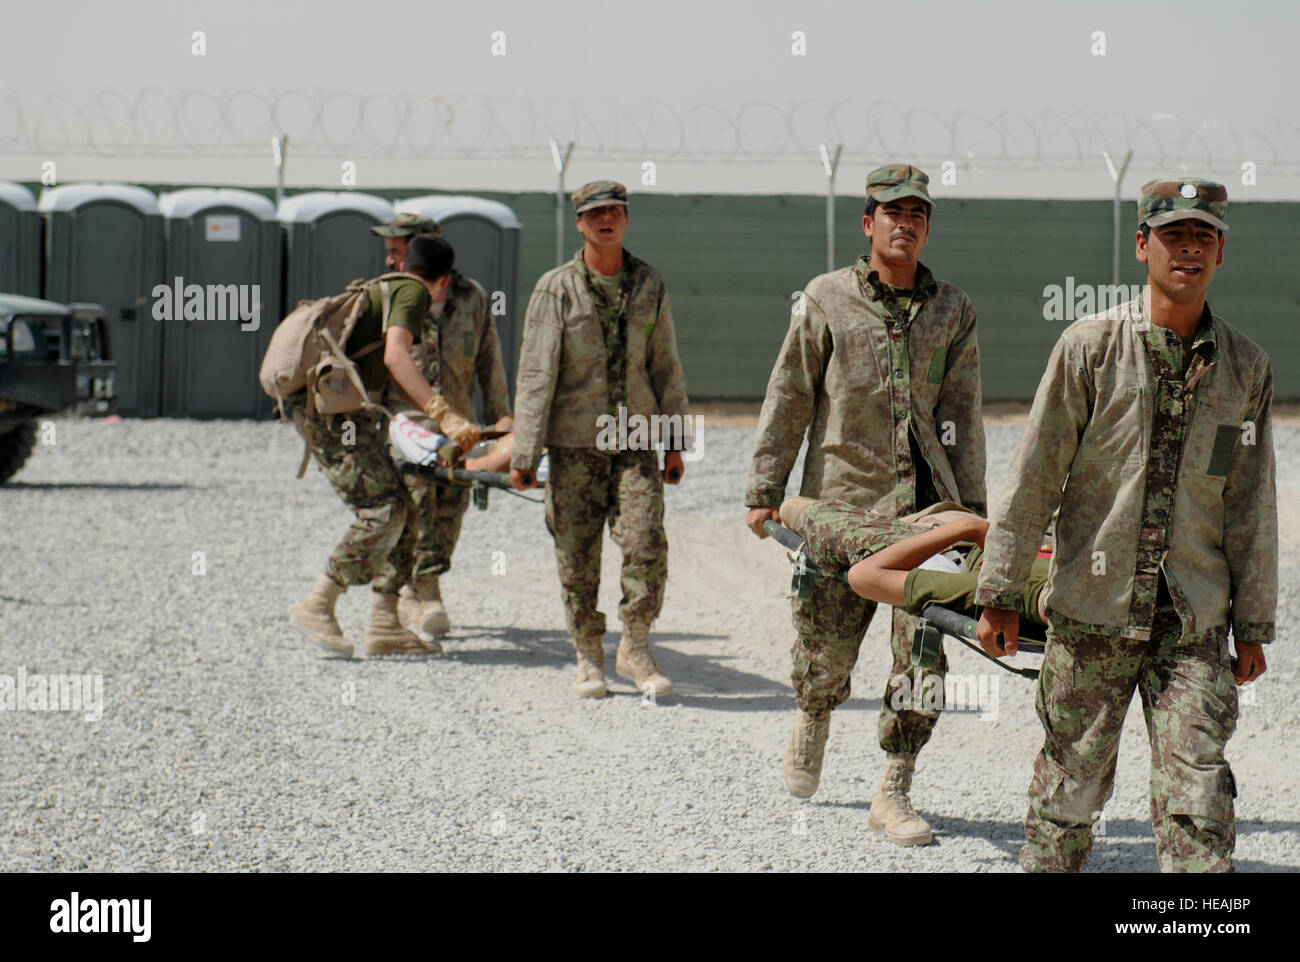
[510,181,689,698]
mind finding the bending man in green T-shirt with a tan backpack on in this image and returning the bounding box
[290,237,477,658]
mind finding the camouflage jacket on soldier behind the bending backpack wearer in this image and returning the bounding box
[390,270,510,425]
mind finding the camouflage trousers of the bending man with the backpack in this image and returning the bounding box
[294,404,415,593]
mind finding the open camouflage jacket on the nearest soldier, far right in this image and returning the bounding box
[975,300,1278,642]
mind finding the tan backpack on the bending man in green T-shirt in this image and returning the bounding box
[257,272,423,417]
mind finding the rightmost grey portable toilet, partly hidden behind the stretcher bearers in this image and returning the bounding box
[394,194,524,400]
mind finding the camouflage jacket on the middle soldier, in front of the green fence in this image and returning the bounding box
[511,251,688,469]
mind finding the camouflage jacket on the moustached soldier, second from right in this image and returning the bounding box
[745,257,985,517]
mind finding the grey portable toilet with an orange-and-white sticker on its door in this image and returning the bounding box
[155,187,283,417]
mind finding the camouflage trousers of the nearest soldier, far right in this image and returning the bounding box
[1021,611,1238,872]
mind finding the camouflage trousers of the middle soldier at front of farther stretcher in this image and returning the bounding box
[546,447,668,638]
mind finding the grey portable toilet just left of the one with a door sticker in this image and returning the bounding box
[36,183,163,417]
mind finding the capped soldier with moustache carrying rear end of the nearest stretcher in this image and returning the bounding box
[745,164,985,845]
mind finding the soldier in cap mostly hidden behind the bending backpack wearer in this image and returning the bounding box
[371,213,514,644]
